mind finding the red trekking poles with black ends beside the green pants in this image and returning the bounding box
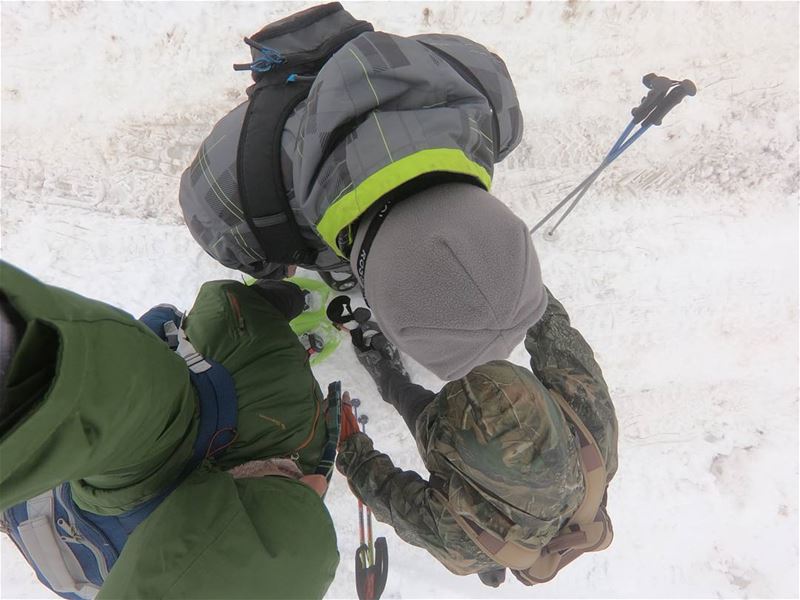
[351,398,389,600]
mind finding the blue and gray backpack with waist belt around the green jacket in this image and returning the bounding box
[0,304,237,600]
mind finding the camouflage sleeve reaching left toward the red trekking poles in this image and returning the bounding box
[336,433,444,554]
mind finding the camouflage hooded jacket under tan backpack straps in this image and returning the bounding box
[337,295,617,575]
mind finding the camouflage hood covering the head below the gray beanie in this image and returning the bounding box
[417,361,584,547]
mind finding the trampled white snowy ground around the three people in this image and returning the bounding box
[0,2,800,598]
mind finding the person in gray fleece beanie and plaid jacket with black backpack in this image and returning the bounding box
[179,3,546,379]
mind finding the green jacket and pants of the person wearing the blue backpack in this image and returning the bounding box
[0,262,339,598]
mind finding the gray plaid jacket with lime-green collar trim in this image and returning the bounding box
[180,21,522,277]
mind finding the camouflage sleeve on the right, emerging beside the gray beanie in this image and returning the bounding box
[525,290,618,481]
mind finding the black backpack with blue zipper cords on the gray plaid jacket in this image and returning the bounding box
[234,2,374,264]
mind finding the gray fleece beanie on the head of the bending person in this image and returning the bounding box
[351,183,547,381]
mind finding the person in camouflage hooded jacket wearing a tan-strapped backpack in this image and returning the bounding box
[336,292,617,586]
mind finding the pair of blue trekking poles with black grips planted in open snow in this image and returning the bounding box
[530,73,697,237]
